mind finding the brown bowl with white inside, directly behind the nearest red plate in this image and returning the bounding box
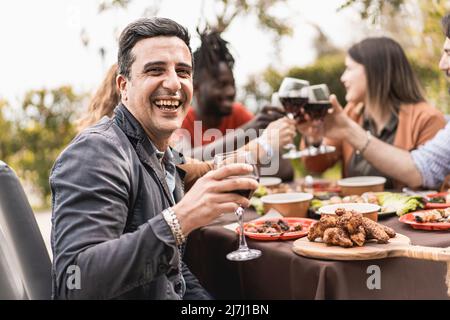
[261,192,313,218]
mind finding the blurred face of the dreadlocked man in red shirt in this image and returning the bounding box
[195,62,236,117]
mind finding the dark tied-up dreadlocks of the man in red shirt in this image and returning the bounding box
[194,29,234,86]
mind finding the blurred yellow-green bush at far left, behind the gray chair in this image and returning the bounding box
[5,86,83,203]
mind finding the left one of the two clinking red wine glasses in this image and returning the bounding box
[278,77,309,159]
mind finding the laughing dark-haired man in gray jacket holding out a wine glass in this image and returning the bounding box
[50,18,257,299]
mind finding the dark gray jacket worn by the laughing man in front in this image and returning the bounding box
[50,104,209,299]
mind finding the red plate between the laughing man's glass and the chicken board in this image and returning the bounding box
[236,218,317,241]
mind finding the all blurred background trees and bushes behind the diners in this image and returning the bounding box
[0,0,450,207]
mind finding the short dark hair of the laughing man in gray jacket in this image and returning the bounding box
[117,17,192,78]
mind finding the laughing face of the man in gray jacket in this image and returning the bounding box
[117,36,193,143]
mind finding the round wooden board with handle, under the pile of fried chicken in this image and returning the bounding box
[293,234,450,262]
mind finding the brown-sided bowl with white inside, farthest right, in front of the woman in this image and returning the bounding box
[337,176,386,196]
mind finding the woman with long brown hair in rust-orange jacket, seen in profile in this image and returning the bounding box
[299,37,446,188]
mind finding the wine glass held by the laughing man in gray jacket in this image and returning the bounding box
[214,151,261,261]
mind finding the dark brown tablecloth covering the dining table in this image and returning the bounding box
[185,211,450,299]
